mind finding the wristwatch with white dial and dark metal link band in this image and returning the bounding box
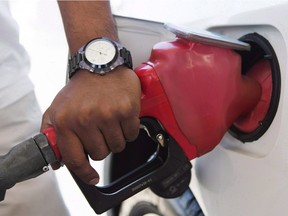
[68,37,133,78]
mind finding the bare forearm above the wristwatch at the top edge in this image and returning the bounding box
[58,0,118,53]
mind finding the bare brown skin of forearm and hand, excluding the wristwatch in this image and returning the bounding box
[41,1,141,185]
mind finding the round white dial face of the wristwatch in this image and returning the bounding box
[85,40,116,65]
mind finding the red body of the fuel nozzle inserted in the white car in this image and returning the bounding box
[136,38,261,159]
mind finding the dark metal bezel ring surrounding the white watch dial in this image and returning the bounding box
[79,37,122,73]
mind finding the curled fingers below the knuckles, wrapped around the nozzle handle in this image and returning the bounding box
[52,118,140,185]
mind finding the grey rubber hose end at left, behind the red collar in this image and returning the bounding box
[0,130,57,201]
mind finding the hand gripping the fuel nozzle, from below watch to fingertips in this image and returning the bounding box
[41,66,141,185]
